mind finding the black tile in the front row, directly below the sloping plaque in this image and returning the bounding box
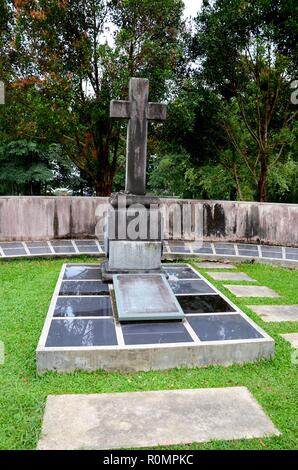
[121,322,192,344]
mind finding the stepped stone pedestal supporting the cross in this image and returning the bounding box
[103,193,163,280]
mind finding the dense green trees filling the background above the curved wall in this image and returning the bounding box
[0,0,298,202]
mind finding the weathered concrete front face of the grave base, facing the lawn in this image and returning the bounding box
[36,337,274,373]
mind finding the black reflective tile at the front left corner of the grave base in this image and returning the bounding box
[46,318,118,347]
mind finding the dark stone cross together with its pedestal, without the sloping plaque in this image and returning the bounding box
[103,78,166,280]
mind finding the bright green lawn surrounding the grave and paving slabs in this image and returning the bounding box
[0,257,298,449]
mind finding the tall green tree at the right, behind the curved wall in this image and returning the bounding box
[193,0,298,201]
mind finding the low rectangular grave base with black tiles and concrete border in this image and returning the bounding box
[36,263,274,373]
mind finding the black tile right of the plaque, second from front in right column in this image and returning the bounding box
[177,295,235,314]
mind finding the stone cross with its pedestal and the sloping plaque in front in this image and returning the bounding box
[103,78,184,321]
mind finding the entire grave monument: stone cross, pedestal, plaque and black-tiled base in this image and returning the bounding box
[36,78,274,372]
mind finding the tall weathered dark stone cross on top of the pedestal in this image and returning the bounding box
[110,78,167,195]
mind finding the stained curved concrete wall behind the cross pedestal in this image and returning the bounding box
[0,197,298,246]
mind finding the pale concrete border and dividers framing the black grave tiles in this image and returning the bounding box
[36,263,275,373]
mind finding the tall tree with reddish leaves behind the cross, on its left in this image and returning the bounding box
[6,0,183,195]
